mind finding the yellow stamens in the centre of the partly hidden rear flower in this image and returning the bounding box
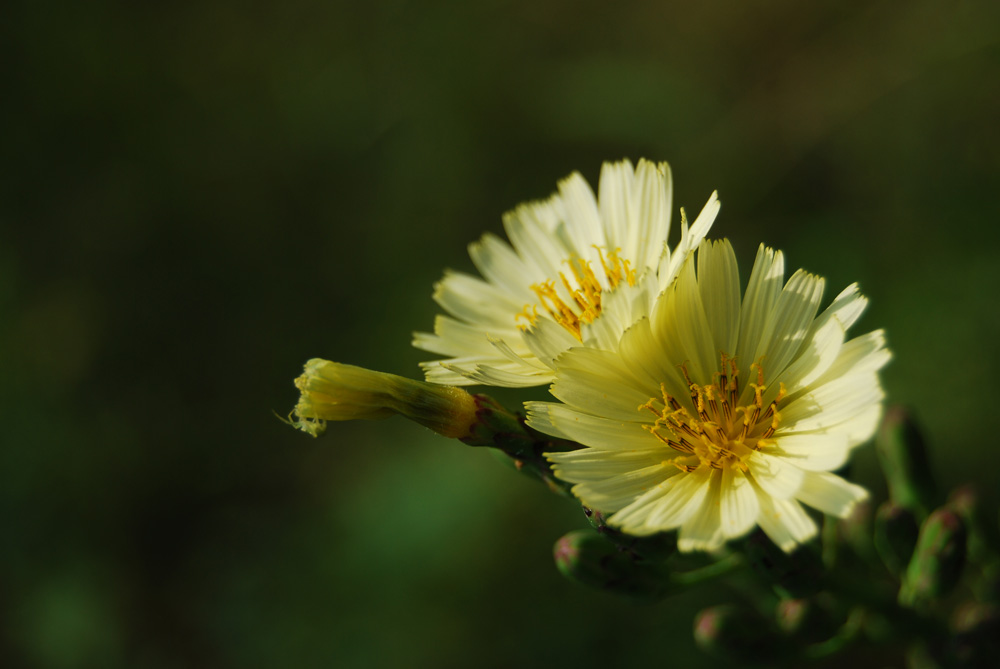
[515,246,636,342]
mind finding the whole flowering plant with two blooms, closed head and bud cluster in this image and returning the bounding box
[280,161,1000,667]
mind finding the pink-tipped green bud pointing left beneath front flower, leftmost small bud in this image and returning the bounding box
[553,530,673,600]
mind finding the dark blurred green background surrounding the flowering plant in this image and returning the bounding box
[0,0,1000,668]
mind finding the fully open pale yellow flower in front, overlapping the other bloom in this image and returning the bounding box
[528,241,890,551]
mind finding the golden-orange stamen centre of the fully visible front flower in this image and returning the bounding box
[639,353,786,472]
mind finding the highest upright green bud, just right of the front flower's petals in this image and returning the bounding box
[875,406,938,518]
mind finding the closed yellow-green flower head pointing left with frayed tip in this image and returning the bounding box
[289,358,476,438]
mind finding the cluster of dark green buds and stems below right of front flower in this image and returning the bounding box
[694,408,1000,669]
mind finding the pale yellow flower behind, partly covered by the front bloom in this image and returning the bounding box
[413,160,719,387]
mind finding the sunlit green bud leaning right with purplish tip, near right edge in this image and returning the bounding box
[899,508,967,608]
